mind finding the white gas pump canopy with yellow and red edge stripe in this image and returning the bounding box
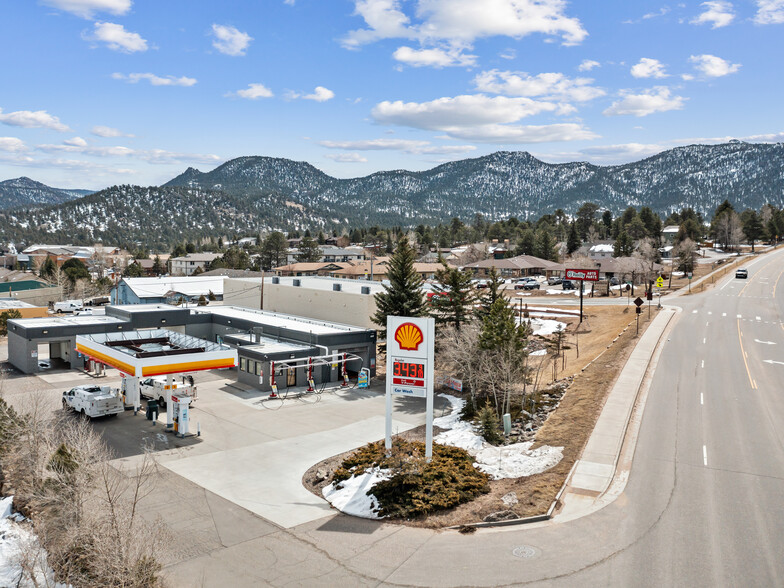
[76,329,237,377]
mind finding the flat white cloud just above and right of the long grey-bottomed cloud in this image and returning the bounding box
[474,69,605,102]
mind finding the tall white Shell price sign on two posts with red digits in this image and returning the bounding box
[385,316,436,461]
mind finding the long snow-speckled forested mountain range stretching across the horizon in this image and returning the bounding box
[0,141,784,247]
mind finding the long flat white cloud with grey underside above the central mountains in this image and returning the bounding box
[371,94,557,132]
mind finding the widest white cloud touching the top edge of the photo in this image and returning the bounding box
[343,0,588,48]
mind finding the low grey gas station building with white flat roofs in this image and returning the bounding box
[8,304,376,390]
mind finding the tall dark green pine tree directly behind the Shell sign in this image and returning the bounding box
[371,237,427,339]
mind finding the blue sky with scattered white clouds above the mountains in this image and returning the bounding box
[0,0,784,190]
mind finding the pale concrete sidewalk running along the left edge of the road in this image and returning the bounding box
[553,308,676,522]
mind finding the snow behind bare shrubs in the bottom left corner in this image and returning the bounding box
[0,496,66,588]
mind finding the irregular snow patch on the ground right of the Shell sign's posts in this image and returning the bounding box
[433,394,563,480]
